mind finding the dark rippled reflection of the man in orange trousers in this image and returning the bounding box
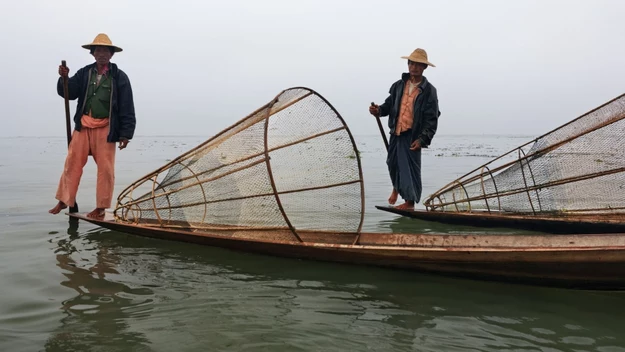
[45,220,152,351]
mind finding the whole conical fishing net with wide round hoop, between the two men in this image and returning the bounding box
[115,88,364,238]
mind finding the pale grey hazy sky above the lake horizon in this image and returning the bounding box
[0,0,625,138]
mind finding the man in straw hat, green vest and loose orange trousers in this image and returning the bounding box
[49,33,135,218]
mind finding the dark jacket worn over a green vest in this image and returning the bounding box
[56,62,136,143]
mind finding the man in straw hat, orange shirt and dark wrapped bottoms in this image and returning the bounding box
[369,49,440,210]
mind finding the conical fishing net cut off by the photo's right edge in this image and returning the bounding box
[424,94,625,214]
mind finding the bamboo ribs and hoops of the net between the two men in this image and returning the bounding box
[115,87,365,239]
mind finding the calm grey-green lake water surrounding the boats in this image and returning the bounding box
[0,136,625,352]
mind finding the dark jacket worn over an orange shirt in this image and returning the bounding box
[380,73,441,148]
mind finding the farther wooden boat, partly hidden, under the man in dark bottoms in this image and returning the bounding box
[376,206,625,234]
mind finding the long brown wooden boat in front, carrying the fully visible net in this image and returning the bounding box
[70,213,625,289]
